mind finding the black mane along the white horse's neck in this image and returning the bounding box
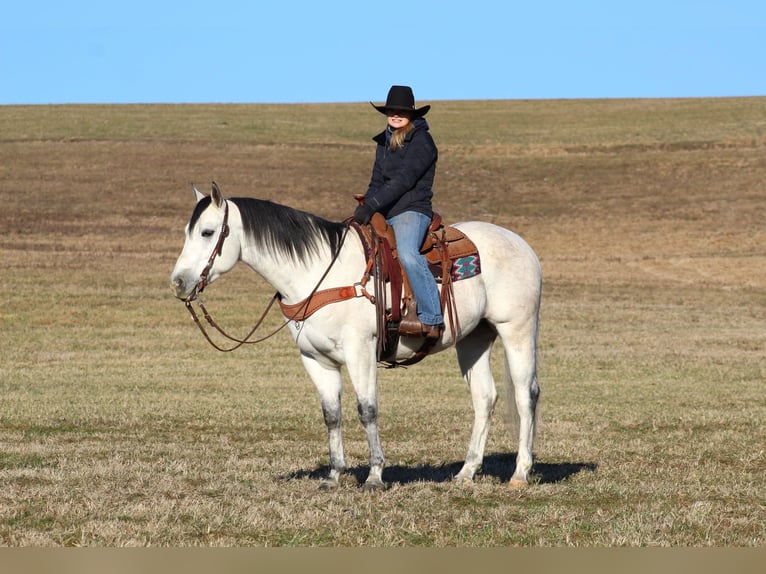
[230,197,347,262]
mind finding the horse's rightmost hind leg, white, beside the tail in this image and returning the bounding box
[496,320,540,488]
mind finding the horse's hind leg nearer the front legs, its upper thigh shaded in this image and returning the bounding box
[455,323,497,482]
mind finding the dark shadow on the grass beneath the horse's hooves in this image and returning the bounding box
[282,453,598,485]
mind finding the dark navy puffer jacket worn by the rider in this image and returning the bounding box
[365,118,439,219]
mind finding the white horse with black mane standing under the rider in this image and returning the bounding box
[171,184,542,490]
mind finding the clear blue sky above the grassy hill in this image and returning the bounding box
[0,0,766,104]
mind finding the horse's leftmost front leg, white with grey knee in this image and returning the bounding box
[301,354,346,489]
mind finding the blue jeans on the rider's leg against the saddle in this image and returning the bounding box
[387,211,444,325]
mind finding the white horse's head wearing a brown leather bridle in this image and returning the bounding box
[170,182,240,300]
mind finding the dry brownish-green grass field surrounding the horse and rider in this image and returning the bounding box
[0,98,766,547]
